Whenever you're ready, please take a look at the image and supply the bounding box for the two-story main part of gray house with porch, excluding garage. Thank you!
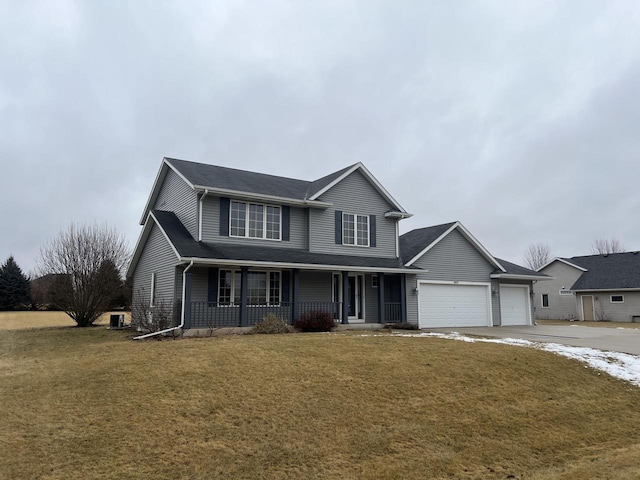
[128,158,413,328]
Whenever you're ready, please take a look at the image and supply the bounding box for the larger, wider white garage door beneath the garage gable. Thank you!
[418,283,491,328]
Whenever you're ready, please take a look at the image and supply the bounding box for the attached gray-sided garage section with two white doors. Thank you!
[400,222,548,328]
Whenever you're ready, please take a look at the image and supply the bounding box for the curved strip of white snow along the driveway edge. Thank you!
[378,332,640,387]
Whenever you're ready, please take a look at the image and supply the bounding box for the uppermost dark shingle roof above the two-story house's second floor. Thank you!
[166,158,353,200]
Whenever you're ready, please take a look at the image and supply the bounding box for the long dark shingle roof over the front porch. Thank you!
[153,210,412,269]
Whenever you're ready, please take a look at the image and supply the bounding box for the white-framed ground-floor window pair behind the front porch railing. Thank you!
[218,269,281,305]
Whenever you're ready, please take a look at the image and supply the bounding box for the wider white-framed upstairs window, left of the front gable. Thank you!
[229,200,282,240]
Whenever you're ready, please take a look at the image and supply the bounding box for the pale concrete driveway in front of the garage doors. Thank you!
[427,325,640,355]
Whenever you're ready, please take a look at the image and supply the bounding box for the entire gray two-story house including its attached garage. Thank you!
[127,158,545,328]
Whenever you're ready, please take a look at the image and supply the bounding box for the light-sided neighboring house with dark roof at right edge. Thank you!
[534,252,640,322]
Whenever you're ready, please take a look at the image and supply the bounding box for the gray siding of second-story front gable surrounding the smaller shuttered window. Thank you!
[309,171,396,258]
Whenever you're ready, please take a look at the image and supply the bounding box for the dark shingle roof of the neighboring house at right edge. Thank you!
[563,252,640,290]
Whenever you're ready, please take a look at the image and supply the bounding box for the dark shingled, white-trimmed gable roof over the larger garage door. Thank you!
[400,222,506,272]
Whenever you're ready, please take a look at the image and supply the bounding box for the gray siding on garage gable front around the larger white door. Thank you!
[406,230,492,325]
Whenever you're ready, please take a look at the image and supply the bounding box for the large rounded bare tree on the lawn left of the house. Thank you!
[38,224,129,327]
